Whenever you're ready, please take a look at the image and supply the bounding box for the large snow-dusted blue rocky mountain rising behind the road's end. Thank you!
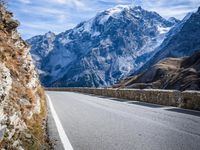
[28,6,179,87]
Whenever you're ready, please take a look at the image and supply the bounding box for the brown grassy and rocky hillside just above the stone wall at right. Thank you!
[114,51,200,91]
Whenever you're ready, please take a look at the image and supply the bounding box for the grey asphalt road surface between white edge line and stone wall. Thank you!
[47,92,200,150]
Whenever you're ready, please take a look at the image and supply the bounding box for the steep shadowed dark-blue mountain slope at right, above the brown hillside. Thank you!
[134,7,200,74]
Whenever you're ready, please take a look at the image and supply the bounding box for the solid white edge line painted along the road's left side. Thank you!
[46,94,73,150]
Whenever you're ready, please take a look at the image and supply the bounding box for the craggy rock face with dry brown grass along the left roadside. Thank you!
[0,5,46,150]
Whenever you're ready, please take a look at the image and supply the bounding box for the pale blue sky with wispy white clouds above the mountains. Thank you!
[8,0,200,39]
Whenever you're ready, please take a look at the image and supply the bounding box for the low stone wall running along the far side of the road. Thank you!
[46,88,200,110]
